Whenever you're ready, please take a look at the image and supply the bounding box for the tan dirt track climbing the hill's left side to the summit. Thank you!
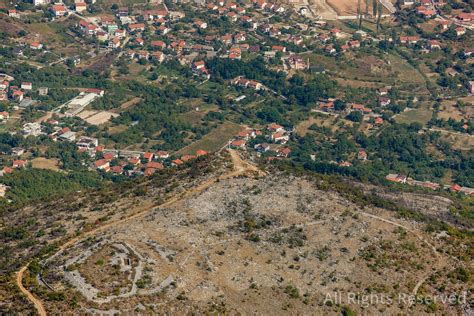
[16,149,265,316]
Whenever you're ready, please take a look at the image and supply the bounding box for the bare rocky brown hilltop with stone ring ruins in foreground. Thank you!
[39,175,472,315]
